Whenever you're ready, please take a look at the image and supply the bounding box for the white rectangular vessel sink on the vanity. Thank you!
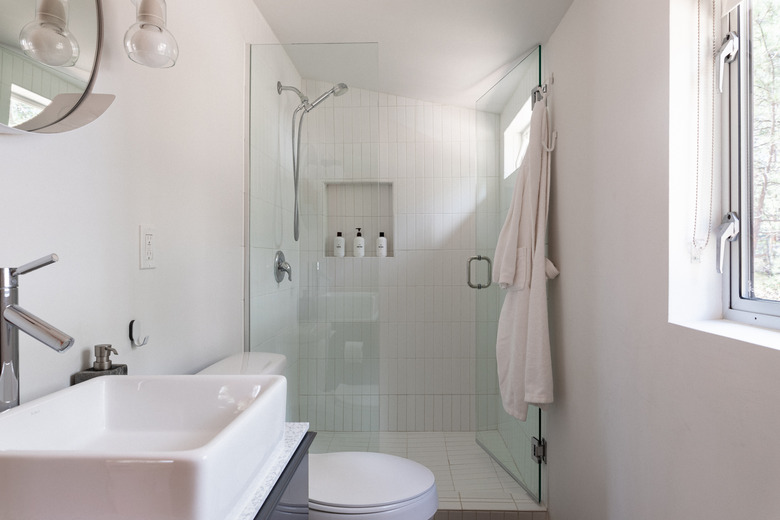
[0,375,287,520]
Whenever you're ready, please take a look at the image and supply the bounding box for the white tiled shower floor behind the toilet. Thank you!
[310,432,545,511]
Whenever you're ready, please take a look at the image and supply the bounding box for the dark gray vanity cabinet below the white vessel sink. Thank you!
[255,432,317,520]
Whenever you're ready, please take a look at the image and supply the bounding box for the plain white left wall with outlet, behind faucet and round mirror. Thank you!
[0,0,276,401]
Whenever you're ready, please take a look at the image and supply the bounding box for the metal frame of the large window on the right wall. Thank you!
[721,0,780,329]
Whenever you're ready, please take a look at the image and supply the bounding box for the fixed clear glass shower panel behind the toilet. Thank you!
[246,43,382,432]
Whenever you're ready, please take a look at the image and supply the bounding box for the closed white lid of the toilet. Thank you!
[309,452,434,508]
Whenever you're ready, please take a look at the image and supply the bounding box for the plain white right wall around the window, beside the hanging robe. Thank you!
[545,0,780,520]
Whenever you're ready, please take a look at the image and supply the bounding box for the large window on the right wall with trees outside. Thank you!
[718,0,780,328]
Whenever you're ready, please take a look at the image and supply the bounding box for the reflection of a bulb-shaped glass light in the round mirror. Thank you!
[19,0,79,67]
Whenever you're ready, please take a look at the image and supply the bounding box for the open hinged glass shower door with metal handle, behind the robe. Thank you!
[469,48,543,501]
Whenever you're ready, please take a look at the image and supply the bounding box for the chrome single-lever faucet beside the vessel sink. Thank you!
[0,254,74,412]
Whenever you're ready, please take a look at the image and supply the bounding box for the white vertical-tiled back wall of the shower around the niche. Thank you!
[301,80,484,431]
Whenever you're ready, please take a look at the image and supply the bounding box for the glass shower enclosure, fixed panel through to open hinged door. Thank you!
[251,39,544,500]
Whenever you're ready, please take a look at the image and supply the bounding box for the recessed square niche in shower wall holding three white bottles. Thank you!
[325,181,395,257]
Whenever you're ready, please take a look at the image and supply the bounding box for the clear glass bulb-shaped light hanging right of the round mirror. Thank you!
[125,0,179,68]
